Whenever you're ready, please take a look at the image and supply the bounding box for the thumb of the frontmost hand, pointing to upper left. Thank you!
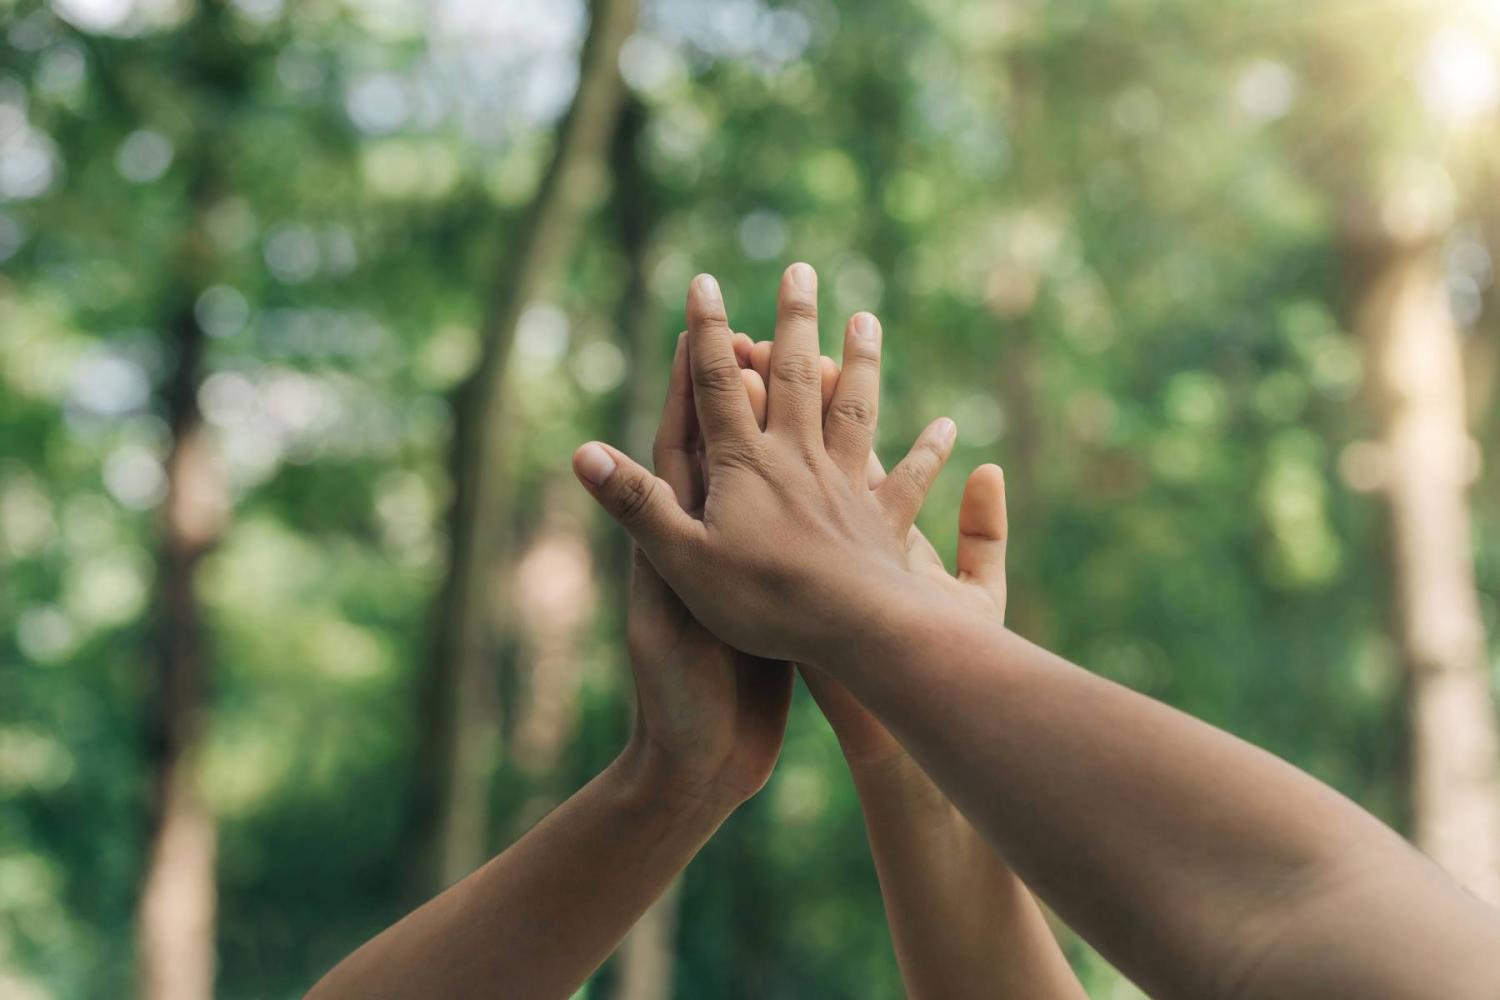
[573,441,704,566]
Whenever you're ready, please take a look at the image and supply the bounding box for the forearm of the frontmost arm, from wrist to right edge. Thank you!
[819,598,1500,997]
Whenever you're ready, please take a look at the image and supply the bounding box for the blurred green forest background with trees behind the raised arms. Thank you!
[0,0,1500,1000]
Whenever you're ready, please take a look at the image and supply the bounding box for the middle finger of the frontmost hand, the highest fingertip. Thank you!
[767,264,822,444]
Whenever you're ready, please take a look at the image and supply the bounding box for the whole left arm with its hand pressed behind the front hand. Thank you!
[309,343,792,1000]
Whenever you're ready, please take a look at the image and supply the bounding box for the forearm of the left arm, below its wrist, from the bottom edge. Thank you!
[309,750,729,1000]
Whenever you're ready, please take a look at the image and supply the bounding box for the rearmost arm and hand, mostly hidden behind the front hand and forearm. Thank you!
[747,335,1086,1000]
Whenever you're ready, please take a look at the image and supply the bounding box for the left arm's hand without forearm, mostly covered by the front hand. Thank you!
[626,334,792,808]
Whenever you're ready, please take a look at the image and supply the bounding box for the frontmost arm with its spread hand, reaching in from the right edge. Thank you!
[575,264,1500,1000]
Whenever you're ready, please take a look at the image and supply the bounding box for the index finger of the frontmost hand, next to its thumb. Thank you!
[687,274,756,460]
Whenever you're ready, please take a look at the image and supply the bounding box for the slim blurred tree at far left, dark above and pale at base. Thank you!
[137,3,254,1000]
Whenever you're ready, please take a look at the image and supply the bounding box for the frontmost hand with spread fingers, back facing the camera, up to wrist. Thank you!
[573,264,956,663]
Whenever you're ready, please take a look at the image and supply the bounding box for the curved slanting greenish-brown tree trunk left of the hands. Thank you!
[414,0,639,888]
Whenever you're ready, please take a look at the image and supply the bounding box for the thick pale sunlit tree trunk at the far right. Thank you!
[1355,230,1500,903]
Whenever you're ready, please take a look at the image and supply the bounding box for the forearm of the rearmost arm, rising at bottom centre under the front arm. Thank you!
[851,753,1085,1000]
